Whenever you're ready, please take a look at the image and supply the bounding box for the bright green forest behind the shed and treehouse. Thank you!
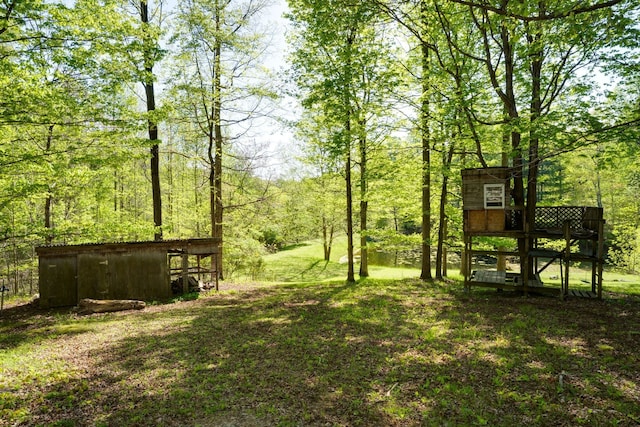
[0,0,640,294]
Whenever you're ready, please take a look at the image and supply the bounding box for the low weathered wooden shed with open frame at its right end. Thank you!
[36,238,220,308]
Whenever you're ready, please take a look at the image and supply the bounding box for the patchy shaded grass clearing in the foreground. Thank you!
[0,279,640,426]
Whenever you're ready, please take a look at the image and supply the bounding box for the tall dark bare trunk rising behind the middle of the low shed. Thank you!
[140,0,162,240]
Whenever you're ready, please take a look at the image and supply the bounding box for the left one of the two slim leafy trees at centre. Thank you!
[289,0,362,283]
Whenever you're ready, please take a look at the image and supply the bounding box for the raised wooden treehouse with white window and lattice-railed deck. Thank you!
[462,167,605,298]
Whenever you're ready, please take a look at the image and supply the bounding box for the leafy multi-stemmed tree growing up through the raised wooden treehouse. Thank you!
[436,0,634,280]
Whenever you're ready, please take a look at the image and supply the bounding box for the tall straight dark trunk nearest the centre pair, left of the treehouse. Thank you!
[420,34,432,280]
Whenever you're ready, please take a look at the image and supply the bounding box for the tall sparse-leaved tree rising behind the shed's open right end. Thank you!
[172,0,273,276]
